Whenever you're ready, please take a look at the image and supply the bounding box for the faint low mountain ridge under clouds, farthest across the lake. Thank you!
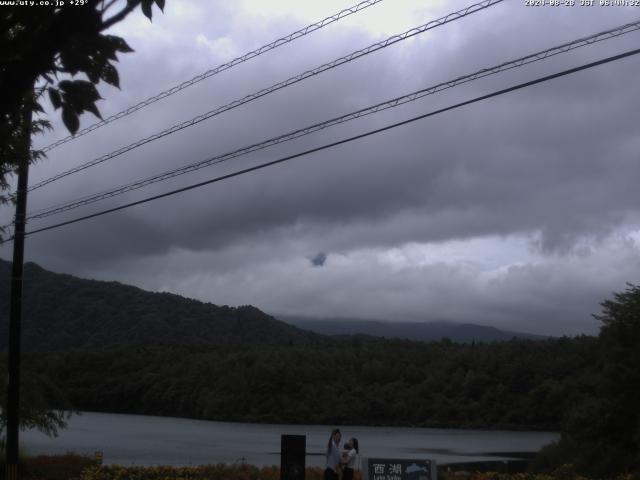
[278,315,548,343]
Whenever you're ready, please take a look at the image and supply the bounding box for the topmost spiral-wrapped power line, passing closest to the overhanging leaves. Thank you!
[42,0,382,153]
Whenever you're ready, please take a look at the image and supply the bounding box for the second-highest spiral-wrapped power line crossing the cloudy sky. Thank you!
[29,0,504,191]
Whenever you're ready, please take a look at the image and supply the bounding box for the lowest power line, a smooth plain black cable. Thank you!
[7,49,640,243]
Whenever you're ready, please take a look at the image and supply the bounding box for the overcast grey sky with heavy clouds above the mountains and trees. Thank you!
[0,0,640,335]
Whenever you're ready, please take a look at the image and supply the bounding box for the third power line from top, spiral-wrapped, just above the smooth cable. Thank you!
[27,20,640,219]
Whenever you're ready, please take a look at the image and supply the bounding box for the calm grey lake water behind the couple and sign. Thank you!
[20,412,559,466]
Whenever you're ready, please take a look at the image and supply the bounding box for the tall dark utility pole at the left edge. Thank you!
[6,90,34,480]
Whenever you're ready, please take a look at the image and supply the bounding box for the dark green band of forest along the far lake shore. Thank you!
[26,337,596,430]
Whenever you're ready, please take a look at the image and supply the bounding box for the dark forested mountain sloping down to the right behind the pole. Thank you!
[0,260,319,351]
